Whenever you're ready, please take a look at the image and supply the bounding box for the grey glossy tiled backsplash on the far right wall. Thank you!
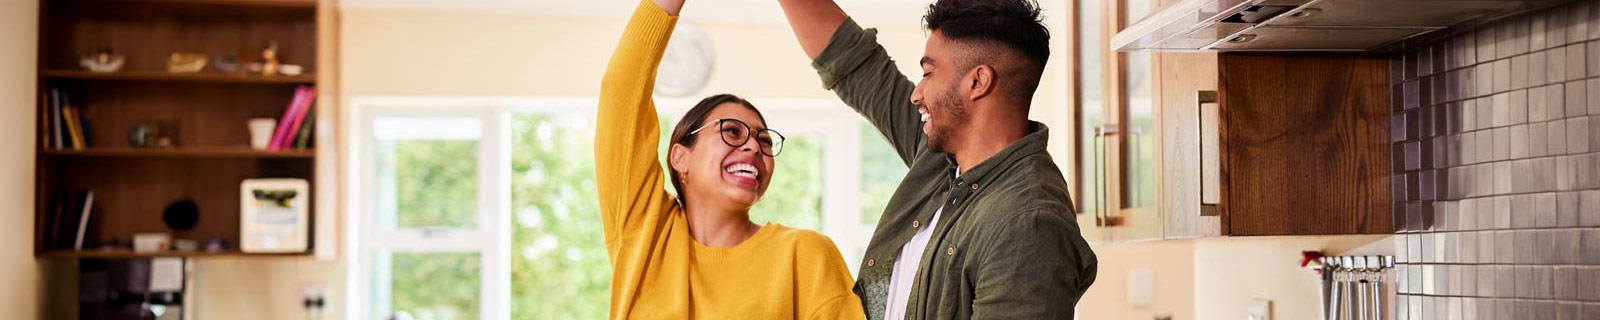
[1390,0,1600,320]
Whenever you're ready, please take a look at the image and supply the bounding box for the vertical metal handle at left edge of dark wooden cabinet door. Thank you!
[1195,90,1222,216]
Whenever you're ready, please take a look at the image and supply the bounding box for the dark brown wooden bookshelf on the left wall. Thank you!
[34,0,336,259]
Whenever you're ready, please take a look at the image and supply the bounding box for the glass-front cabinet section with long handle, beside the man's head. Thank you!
[1072,0,1163,242]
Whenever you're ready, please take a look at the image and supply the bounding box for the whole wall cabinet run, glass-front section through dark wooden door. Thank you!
[1070,0,1394,243]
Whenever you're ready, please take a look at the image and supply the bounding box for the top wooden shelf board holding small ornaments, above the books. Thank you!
[38,70,317,85]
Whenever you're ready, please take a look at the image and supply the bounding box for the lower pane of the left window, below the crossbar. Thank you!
[387,253,483,320]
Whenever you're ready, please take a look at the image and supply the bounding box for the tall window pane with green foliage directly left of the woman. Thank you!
[510,114,611,318]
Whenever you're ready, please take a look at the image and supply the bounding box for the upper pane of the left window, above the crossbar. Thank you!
[373,117,482,229]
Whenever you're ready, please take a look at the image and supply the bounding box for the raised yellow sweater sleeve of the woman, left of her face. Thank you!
[594,0,678,262]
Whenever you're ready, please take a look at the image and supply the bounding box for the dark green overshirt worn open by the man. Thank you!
[811,19,1096,320]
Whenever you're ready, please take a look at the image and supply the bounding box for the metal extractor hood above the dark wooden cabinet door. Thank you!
[1110,0,1570,51]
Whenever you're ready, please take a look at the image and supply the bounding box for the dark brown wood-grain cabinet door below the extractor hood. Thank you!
[1219,53,1394,235]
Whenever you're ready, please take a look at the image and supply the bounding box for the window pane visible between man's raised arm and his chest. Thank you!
[859,123,909,225]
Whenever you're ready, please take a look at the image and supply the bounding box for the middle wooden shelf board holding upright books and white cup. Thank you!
[40,147,317,158]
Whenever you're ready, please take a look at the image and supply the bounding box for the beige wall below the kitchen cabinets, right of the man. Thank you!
[1078,235,1394,320]
